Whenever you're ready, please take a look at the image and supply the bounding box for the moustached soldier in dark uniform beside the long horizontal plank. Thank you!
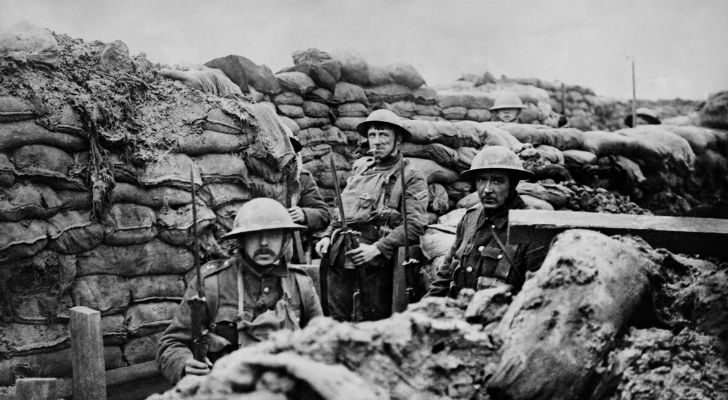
[427,146,545,298]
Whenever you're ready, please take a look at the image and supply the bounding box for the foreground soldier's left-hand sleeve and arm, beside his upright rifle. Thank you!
[157,280,207,383]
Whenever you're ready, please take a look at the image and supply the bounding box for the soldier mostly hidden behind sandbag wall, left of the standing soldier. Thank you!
[288,134,330,263]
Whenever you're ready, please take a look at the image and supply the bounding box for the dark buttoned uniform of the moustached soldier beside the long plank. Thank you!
[427,194,546,297]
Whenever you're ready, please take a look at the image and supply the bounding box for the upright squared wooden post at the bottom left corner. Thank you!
[71,306,106,400]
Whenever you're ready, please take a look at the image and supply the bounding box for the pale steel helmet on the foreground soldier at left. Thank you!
[221,197,306,239]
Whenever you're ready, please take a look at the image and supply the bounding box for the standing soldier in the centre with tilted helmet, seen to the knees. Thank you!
[316,110,428,320]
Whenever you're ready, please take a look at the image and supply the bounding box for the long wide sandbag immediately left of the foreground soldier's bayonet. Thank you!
[76,240,194,276]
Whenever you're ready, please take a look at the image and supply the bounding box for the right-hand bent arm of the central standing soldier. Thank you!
[375,170,428,259]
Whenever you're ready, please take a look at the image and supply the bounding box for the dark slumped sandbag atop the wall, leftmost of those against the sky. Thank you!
[205,55,281,94]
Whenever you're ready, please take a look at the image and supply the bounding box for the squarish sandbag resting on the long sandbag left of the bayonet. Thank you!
[104,203,157,246]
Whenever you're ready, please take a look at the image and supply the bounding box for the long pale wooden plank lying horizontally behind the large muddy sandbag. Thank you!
[508,210,728,258]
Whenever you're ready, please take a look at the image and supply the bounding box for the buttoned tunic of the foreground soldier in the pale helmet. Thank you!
[157,255,323,382]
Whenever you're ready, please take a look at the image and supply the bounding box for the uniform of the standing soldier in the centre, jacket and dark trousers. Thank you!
[321,153,428,320]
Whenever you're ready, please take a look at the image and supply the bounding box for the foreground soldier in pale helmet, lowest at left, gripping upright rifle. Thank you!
[157,198,323,383]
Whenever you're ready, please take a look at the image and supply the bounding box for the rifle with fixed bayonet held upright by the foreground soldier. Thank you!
[187,168,207,362]
